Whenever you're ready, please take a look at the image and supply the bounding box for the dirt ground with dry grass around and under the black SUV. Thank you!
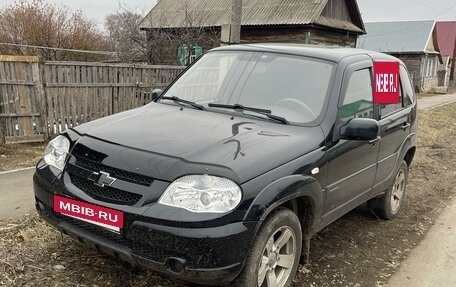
[0,104,456,287]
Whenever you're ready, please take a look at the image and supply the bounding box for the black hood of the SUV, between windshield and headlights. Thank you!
[73,103,324,183]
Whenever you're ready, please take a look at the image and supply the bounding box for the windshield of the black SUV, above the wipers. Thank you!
[160,52,334,123]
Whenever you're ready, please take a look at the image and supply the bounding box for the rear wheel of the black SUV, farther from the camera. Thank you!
[367,161,408,220]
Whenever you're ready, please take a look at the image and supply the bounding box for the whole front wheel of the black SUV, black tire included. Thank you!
[231,208,302,287]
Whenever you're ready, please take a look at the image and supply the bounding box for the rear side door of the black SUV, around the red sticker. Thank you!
[374,66,414,192]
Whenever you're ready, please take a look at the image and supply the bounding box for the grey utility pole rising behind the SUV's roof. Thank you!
[221,0,242,46]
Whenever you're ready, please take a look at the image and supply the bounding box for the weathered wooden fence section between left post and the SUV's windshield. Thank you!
[43,62,182,134]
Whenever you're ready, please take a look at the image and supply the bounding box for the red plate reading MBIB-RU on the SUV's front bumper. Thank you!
[54,195,124,232]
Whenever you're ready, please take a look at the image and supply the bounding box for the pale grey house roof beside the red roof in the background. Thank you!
[357,20,440,54]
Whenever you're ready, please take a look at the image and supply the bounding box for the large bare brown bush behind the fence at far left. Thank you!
[0,0,107,60]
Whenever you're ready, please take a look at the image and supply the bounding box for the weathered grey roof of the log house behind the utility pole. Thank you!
[140,0,364,34]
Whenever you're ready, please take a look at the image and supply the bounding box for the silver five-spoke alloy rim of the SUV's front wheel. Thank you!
[258,226,296,287]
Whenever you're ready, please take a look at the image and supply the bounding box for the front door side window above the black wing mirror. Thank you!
[339,69,374,125]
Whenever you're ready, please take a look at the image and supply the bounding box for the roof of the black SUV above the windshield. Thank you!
[214,43,401,63]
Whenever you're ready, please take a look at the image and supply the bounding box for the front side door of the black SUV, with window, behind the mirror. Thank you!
[324,60,379,223]
